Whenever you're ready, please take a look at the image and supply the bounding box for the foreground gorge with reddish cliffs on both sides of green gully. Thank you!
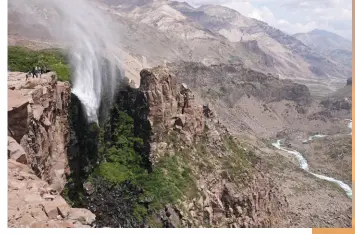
[8,67,289,227]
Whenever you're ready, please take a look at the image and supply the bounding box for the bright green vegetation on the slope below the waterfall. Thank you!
[86,106,196,220]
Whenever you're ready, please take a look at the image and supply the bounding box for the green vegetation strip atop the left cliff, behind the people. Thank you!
[8,46,71,81]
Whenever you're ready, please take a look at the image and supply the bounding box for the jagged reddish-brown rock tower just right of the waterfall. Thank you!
[139,67,204,163]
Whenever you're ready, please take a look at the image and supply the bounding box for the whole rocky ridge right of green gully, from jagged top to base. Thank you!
[139,67,288,227]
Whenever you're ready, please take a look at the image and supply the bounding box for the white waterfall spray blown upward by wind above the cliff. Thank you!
[9,0,122,122]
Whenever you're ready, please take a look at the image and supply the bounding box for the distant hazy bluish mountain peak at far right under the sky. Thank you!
[294,29,352,69]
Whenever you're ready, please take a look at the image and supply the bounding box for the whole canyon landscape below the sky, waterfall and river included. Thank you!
[7,0,352,228]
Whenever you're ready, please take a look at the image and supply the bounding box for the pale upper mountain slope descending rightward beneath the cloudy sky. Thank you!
[170,2,350,77]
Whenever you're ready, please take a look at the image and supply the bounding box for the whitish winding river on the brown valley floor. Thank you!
[272,120,353,199]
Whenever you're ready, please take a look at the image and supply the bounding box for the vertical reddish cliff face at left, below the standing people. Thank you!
[8,72,70,192]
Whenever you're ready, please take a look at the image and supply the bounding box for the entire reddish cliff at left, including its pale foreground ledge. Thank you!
[8,72,95,228]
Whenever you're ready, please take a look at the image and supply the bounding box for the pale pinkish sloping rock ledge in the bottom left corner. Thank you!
[8,159,95,228]
